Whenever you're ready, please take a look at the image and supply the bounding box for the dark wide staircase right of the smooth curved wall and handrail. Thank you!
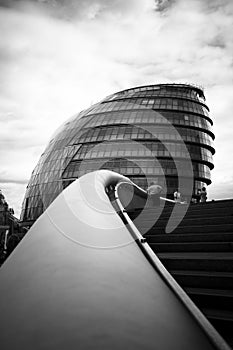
[128,200,233,348]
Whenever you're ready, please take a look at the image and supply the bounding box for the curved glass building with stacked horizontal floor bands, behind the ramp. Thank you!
[21,84,215,222]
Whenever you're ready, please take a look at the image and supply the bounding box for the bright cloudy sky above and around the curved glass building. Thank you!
[0,0,233,216]
